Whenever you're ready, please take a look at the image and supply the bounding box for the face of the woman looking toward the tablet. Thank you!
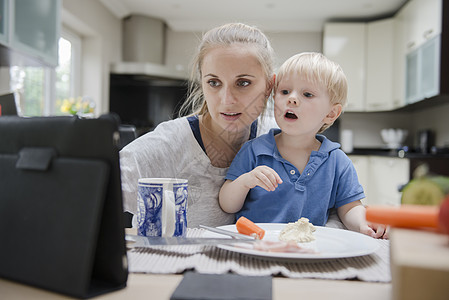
[201,44,271,133]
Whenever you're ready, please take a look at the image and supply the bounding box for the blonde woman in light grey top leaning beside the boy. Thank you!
[120,23,274,227]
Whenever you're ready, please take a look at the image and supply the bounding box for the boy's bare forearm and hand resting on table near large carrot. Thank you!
[337,200,387,238]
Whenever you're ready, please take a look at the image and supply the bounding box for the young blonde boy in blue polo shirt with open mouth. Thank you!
[219,53,385,238]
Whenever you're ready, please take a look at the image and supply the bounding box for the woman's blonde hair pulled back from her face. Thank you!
[179,23,274,116]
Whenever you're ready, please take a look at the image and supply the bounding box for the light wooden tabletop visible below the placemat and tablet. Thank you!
[0,274,392,300]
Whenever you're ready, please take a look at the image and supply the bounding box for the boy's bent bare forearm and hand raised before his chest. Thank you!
[218,166,282,213]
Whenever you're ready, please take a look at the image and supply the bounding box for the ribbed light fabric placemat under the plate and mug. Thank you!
[128,229,391,282]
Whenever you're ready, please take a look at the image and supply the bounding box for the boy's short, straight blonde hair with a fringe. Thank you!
[275,52,348,133]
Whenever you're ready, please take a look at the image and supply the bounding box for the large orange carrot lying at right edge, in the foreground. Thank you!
[366,204,439,228]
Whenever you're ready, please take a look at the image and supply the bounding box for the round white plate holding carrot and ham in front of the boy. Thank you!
[203,223,379,259]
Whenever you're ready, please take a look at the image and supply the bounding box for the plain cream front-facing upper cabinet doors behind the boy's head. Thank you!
[323,18,405,111]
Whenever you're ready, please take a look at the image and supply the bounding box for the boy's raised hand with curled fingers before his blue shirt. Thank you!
[242,166,282,191]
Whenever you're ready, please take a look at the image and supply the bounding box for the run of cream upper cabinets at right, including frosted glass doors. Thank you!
[323,0,448,111]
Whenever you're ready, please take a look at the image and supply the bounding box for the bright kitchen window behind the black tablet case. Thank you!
[10,28,81,116]
